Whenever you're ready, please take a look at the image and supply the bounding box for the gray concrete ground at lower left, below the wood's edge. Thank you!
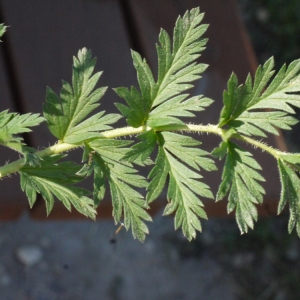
[0,214,236,300]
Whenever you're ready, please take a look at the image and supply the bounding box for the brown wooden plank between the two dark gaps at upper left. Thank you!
[1,0,136,217]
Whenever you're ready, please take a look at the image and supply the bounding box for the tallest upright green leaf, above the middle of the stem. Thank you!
[115,8,211,127]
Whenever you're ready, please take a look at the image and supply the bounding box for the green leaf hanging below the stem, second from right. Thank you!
[216,141,265,233]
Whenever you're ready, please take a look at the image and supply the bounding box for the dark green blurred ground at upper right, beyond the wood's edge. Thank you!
[239,0,300,152]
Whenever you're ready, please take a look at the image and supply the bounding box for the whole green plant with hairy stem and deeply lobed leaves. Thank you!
[0,8,300,241]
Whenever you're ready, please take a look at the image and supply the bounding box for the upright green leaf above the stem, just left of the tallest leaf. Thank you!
[43,48,112,143]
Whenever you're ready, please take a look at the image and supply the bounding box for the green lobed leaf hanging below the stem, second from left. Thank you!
[88,139,152,241]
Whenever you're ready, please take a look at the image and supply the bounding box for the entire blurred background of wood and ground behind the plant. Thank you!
[0,0,300,300]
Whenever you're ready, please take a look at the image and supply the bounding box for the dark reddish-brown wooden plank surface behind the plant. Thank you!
[0,0,285,220]
